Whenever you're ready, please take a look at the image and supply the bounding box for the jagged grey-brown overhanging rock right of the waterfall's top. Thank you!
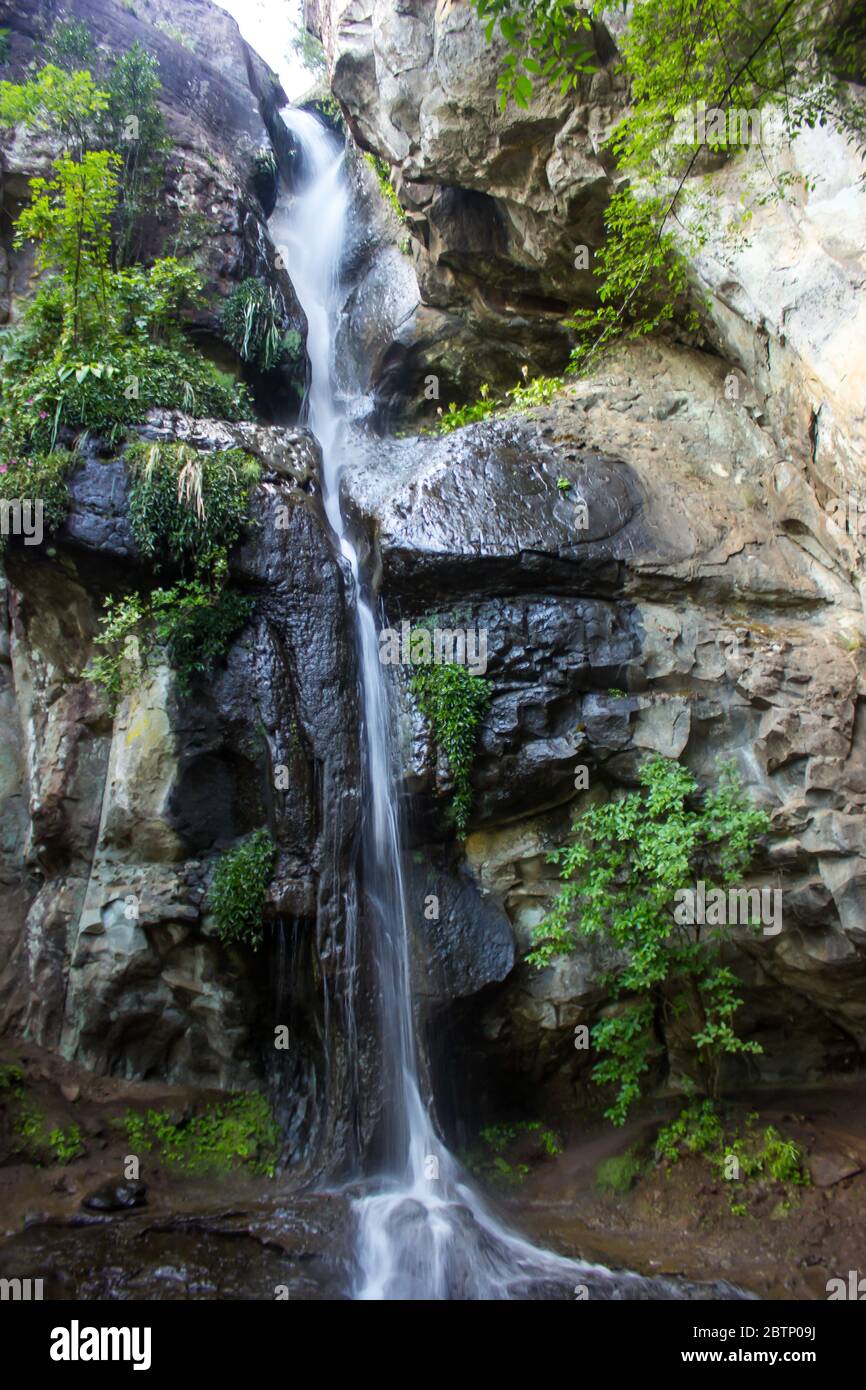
[306,0,623,393]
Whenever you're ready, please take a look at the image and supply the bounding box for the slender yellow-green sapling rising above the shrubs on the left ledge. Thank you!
[15,150,121,346]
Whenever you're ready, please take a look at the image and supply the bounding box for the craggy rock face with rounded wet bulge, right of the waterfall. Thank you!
[346,345,866,1115]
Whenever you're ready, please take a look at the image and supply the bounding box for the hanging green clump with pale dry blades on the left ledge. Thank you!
[125,442,261,566]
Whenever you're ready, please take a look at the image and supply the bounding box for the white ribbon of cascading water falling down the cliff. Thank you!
[271,110,739,1300]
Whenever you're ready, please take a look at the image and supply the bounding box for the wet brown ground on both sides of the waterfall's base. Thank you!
[0,1048,866,1301]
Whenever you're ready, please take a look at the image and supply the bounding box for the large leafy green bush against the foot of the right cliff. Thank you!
[527,758,769,1125]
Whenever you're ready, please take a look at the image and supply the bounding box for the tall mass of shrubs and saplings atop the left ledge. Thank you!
[0,54,250,461]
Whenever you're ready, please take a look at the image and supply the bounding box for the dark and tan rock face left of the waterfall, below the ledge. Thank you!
[1,413,360,1156]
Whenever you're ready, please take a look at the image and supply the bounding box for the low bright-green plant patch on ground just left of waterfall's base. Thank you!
[121,1093,279,1177]
